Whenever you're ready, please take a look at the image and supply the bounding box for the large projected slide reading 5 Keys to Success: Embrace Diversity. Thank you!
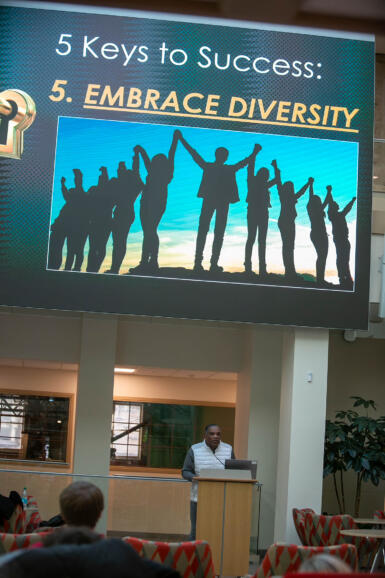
[0,2,374,329]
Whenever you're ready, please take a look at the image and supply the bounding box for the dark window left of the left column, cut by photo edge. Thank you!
[0,393,70,462]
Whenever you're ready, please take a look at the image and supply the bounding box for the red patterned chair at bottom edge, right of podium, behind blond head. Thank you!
[254,544,357,578]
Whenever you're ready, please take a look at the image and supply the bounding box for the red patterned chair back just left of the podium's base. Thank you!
[123,536,215,578]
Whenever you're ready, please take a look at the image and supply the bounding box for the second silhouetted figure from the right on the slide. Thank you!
[306,177,329,285]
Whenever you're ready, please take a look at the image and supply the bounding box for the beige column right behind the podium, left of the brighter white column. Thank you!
[235,327,282,549]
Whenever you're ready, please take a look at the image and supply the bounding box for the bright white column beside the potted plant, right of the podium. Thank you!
[274,328,329,543]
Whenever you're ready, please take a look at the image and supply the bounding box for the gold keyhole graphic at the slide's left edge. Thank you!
[0,89,36,159]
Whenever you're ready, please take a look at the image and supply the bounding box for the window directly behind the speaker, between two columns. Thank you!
[111,401,235,469]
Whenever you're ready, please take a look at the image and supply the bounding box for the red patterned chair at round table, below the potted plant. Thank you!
[305,513,378,567]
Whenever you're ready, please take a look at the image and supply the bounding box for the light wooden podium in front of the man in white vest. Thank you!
[194,470,257,576]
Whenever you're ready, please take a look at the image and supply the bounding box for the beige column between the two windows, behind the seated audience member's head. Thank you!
[73,315,117,532]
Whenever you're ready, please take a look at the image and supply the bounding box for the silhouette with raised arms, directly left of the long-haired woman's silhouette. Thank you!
[106,151,144,273]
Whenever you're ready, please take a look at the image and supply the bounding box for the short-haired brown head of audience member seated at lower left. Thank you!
[59,482,104,529]
